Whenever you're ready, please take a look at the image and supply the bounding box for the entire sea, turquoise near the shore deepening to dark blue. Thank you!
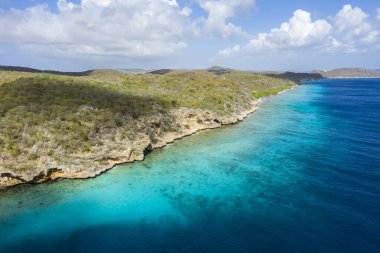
[0,79,380,253]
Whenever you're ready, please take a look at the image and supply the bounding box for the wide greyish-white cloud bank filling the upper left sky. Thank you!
[0,0,192,57]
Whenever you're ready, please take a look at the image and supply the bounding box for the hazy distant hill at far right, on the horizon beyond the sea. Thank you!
[314,68,380,78]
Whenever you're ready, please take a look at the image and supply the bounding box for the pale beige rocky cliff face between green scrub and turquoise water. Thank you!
[0,101,259,189]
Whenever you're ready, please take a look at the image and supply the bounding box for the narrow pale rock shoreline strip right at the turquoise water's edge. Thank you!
[0,86,296,191]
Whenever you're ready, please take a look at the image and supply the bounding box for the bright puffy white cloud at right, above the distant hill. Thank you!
[219,5,380,56]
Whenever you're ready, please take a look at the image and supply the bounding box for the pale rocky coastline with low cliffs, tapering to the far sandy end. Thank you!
[0,86,296,191]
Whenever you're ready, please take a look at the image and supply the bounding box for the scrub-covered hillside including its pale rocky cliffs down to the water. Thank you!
[0,69,294,187]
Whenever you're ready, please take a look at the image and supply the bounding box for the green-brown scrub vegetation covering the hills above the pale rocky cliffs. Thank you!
[0,70,294,167]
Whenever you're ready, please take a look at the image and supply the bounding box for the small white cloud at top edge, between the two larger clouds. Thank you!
[197,0,255,38]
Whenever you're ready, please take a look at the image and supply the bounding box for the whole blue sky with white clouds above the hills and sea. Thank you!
[0,0,380,71]
